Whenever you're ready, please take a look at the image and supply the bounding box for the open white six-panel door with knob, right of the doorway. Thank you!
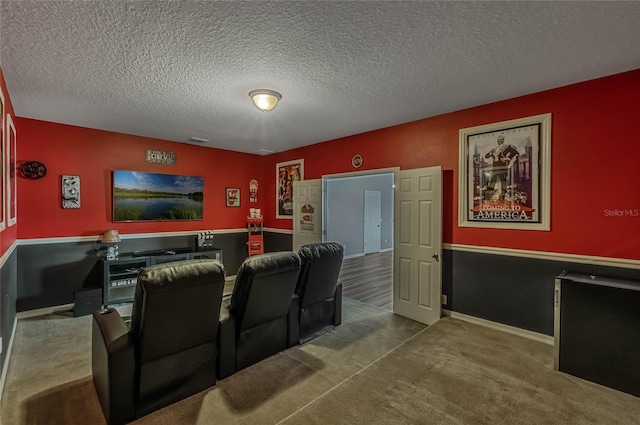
[393,166,442,325]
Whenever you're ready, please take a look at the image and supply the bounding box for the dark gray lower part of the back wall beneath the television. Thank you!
[16,231,247,312]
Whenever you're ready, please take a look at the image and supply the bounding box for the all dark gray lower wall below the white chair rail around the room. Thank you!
[17,231,640,338]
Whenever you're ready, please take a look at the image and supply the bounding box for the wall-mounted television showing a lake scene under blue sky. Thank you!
[113,170,204,221]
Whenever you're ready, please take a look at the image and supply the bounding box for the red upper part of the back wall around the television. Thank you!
[16,118,264,239]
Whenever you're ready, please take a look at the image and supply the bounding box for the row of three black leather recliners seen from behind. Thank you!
[92,242,343,424]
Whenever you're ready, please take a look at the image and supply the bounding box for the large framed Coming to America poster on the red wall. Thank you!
[458,114,551,230]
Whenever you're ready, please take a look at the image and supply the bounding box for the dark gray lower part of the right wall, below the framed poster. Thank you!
[443,251,640,335]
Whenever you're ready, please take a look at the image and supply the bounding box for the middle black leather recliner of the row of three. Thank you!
[218,251,300,379]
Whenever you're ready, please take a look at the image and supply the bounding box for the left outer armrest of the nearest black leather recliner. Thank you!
[91,308,135,425]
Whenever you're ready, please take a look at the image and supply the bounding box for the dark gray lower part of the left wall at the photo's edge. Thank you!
[0,251,17,370]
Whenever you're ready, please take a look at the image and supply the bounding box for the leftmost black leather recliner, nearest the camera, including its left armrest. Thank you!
[92,260,225,424]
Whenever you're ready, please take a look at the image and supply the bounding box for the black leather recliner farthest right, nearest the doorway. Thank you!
[291,242,344,345]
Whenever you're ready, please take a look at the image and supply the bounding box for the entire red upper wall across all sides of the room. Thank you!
[6,70,640,260]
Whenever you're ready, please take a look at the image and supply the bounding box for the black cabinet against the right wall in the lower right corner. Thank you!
[554,271,640,396]
